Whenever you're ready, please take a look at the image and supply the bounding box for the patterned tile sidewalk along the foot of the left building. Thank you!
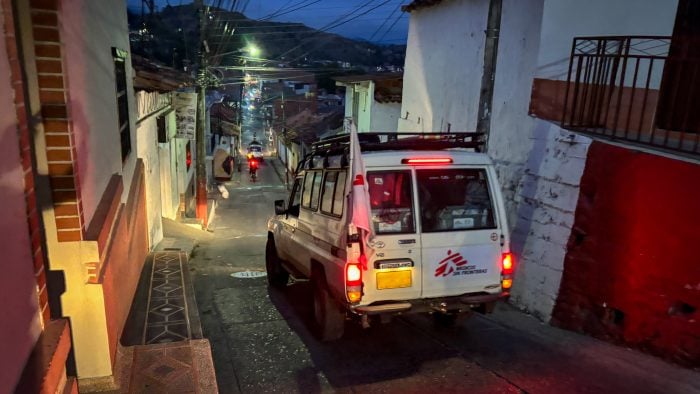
[112,220,218,394]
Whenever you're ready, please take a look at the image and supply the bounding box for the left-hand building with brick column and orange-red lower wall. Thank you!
[0,0,151,392]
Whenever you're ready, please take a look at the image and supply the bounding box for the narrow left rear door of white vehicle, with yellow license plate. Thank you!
[363,169,422,302]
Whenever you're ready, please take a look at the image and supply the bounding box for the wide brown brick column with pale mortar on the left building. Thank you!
[30,0,85,242]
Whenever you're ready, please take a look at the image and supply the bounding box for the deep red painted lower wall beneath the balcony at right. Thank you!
[552,142,700,366]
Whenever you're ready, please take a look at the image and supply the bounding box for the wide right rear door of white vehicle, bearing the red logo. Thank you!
[416,168,502,298]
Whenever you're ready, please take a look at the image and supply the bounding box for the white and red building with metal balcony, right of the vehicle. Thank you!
[398,0,700,365]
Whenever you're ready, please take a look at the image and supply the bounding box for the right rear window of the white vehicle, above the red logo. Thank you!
[416,169,496,232]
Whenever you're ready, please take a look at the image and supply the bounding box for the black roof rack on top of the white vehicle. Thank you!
[296,132,484,172]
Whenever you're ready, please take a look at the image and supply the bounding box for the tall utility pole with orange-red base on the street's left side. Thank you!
[195,0,209,228]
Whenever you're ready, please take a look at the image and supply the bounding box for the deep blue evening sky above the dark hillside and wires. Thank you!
[127,0,411,44]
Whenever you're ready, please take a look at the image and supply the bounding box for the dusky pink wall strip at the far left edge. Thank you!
[0,3,41,393]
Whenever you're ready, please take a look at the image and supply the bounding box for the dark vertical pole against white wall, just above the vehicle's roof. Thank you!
[476,0,503,152]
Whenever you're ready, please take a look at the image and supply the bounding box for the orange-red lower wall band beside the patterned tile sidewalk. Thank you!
[100,160,148,366]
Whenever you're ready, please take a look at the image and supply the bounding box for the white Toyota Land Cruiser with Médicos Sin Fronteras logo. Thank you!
[266,133,513,340]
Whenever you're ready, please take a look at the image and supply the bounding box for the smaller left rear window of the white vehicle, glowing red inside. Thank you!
[367,171,415,234]
